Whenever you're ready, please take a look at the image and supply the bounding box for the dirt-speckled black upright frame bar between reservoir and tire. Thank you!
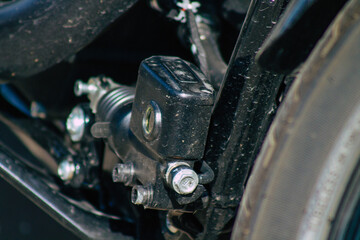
[200,0,288,239]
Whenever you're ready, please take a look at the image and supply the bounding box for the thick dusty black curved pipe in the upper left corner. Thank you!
[0,0,137,80]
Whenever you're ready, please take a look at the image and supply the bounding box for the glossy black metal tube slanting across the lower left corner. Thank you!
[0,147,132,239]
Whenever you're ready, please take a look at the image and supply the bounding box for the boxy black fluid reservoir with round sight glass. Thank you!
[130,56,215,160]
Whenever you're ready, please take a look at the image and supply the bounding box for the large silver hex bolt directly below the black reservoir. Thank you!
[166,163,199,195]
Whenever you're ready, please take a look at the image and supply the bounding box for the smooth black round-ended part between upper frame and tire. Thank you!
[258,0,347,73]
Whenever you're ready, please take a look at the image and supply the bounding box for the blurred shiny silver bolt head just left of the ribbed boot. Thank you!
[66,106,86,142]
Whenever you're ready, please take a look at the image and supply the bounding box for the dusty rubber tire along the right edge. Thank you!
[232,0,360,240]
